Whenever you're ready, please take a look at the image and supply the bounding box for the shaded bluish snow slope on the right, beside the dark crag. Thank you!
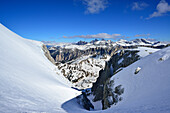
[106,47,170,113]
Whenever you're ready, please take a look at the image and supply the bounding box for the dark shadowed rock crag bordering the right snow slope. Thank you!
[92,50,139,109]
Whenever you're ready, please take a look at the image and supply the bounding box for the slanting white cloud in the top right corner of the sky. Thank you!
[146,0,170,19]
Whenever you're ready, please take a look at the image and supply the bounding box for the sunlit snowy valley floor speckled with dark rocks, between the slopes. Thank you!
[57,55,110,89]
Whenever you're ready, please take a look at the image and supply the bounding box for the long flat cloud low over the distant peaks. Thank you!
[63,33,125,39]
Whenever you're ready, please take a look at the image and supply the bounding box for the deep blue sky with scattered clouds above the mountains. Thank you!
[0,0,170,42]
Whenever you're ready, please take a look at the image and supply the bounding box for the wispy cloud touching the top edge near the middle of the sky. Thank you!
[83,0,108,14]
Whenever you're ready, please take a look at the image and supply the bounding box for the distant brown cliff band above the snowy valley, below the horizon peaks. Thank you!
[50,46,122,63]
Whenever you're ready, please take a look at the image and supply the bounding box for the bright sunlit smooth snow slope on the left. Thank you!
[0,24,79,113]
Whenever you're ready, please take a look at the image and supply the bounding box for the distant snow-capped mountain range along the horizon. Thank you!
[43,38,170,50]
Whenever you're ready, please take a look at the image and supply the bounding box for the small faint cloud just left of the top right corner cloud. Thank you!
[132,2,148,10]
